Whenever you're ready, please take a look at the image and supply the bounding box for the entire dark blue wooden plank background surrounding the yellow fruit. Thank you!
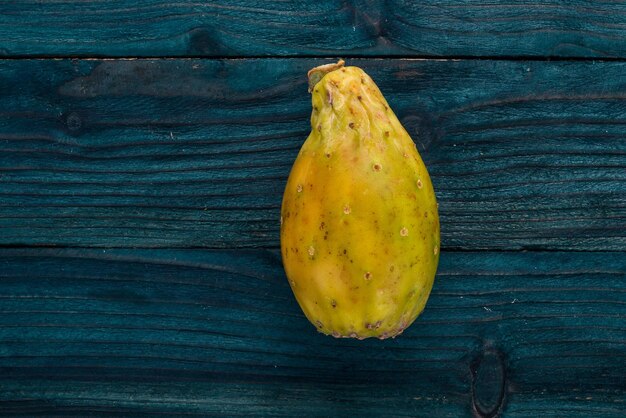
[0,0,626,417]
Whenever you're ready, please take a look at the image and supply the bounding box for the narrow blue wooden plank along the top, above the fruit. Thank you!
[0,0,626,58]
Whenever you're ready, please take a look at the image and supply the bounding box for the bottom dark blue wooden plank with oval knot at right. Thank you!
[0,249,626,417]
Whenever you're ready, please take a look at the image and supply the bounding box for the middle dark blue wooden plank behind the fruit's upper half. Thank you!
[0,59,626,250]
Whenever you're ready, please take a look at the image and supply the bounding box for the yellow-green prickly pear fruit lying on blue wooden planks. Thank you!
[281,61,440,339]
